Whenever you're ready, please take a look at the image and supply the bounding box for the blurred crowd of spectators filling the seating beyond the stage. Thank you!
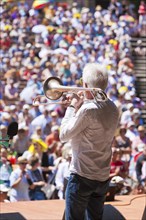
[0,0,146,201]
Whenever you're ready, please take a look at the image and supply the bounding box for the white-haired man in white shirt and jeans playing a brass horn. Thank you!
[60,63,119,220]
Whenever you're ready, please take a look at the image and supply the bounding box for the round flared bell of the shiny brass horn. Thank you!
[43,77,63,100]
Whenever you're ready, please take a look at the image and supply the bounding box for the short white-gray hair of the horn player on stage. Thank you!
[82,63,108,90]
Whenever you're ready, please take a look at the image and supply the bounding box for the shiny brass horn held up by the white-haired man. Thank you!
[33,77,107,106]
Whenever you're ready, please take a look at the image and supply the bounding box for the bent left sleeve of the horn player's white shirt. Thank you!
[60,107,88,142]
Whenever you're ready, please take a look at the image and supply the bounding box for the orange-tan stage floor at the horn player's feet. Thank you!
[0,194,146,220]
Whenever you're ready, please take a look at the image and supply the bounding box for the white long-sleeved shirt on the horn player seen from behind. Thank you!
[60,100,119,181]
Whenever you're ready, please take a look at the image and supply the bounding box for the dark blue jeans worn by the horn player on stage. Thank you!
[65,174,109,220]
